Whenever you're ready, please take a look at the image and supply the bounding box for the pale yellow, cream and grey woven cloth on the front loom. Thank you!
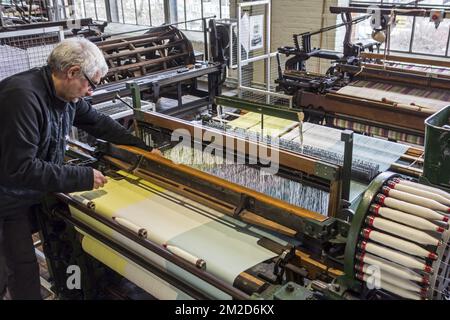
[71,172,275,284]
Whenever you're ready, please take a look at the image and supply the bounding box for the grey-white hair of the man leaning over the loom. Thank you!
[47,38,108,79]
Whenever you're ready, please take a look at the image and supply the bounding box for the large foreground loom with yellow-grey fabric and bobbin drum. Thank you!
[39,76,450,299]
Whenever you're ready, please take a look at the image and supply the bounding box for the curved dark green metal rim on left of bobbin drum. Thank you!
[339,171,399,290]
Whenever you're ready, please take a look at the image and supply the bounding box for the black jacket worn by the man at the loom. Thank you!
[0,67,149,216]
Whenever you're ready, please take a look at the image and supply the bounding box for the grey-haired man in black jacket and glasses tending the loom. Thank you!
[0,38,159,299]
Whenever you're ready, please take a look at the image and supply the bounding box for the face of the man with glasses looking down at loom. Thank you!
[62,66,101,102]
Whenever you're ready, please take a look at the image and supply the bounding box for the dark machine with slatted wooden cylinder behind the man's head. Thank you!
[84,19,226,122]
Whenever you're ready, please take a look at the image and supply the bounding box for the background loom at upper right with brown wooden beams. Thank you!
[276,5,450,145]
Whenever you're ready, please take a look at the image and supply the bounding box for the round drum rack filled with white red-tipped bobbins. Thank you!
[344,172,450,299]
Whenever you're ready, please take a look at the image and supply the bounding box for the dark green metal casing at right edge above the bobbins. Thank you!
[421,106,450,191]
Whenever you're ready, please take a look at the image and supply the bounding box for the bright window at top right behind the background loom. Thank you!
[350,0,450,57]
